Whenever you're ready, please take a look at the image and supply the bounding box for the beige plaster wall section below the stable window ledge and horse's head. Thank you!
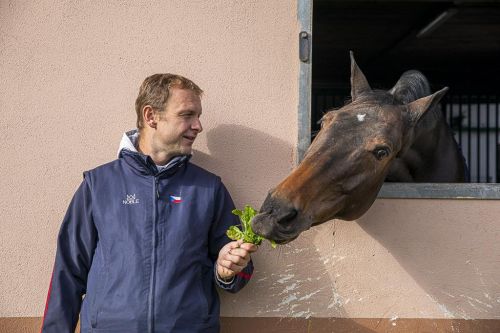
[223,199,500,320]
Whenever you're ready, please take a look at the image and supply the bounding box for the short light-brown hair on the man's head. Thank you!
[135,73,203,130]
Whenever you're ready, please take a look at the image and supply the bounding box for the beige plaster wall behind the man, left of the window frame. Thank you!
[0,0,298,317]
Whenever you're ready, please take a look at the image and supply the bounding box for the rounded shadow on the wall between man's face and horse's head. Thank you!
[192,124,293,208]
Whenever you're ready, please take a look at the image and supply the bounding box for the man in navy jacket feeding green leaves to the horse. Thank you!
[42,74,257,333]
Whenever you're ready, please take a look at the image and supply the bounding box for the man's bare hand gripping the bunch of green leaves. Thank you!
[217,240,257,280]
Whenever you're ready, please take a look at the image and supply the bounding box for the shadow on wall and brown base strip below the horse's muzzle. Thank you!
[221,224,376,333]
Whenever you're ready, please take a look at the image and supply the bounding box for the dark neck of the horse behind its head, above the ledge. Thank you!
[388,108,465,182]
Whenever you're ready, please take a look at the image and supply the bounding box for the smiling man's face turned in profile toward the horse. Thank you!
[154,88,203,157]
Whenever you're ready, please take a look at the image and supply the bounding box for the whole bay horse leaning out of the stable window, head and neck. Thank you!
[252,52,466,243]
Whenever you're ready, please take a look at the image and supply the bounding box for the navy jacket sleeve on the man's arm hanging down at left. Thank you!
[41,179,97,333]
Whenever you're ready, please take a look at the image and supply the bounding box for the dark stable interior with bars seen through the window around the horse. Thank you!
[311,0,500,183]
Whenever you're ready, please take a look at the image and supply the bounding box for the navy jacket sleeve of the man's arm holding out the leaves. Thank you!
[209,178,253,293]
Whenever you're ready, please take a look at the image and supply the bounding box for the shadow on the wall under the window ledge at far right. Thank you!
[357,200,500,319]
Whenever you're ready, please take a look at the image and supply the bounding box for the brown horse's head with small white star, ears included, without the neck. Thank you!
[252,52,447,243]
